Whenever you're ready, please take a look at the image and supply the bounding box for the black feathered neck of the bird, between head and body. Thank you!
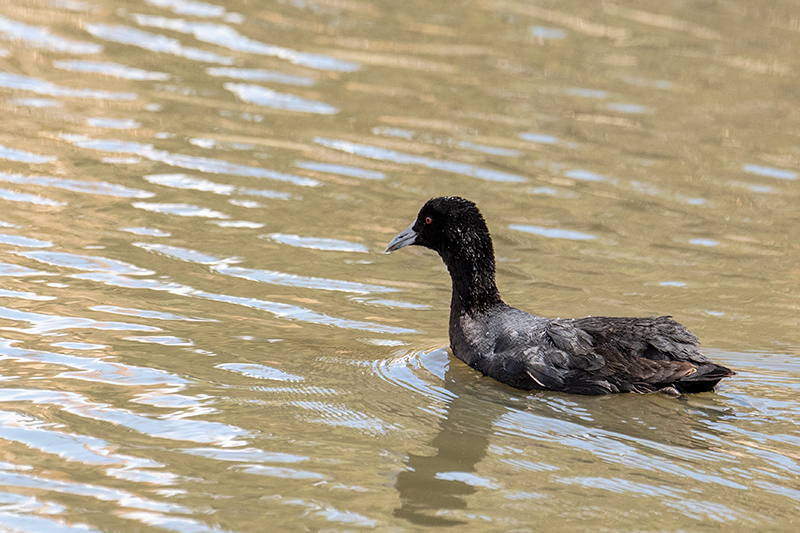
[442,242,503,314]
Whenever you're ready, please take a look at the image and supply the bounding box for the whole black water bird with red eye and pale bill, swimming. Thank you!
[386,196,735,396]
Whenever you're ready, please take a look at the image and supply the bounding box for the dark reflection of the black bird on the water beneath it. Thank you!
[394,349,734,527]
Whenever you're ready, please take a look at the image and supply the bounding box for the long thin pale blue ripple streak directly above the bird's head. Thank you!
[314,137,527,183]
